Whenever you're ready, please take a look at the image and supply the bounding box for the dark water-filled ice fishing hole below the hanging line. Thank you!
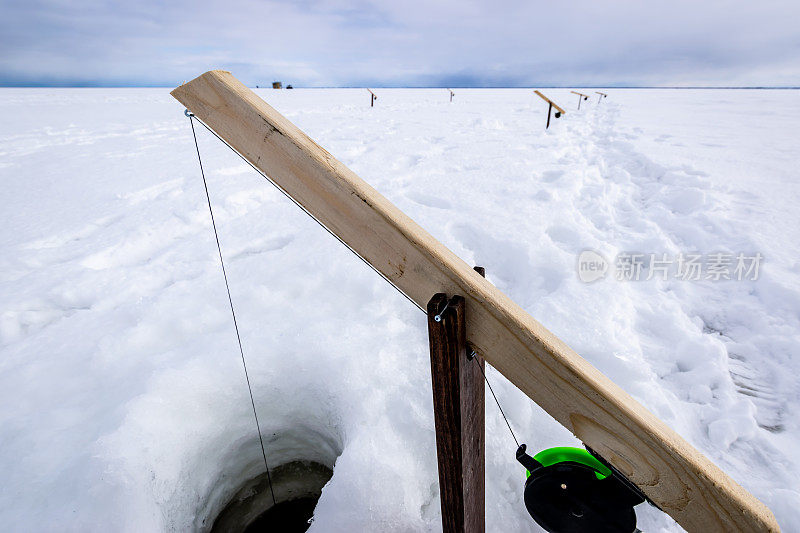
[211,461,333,533]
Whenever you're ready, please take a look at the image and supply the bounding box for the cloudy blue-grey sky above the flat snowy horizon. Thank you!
[0,0,800,87]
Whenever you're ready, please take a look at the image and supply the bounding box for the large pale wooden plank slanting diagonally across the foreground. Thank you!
[172,71,779,532]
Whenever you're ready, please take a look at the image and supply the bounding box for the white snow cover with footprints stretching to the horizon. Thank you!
[0,89,800,533]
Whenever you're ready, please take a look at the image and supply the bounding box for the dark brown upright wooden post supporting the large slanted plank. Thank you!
[427,293,486,533]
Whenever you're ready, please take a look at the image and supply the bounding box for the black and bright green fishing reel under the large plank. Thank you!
[517,444,647,533]
